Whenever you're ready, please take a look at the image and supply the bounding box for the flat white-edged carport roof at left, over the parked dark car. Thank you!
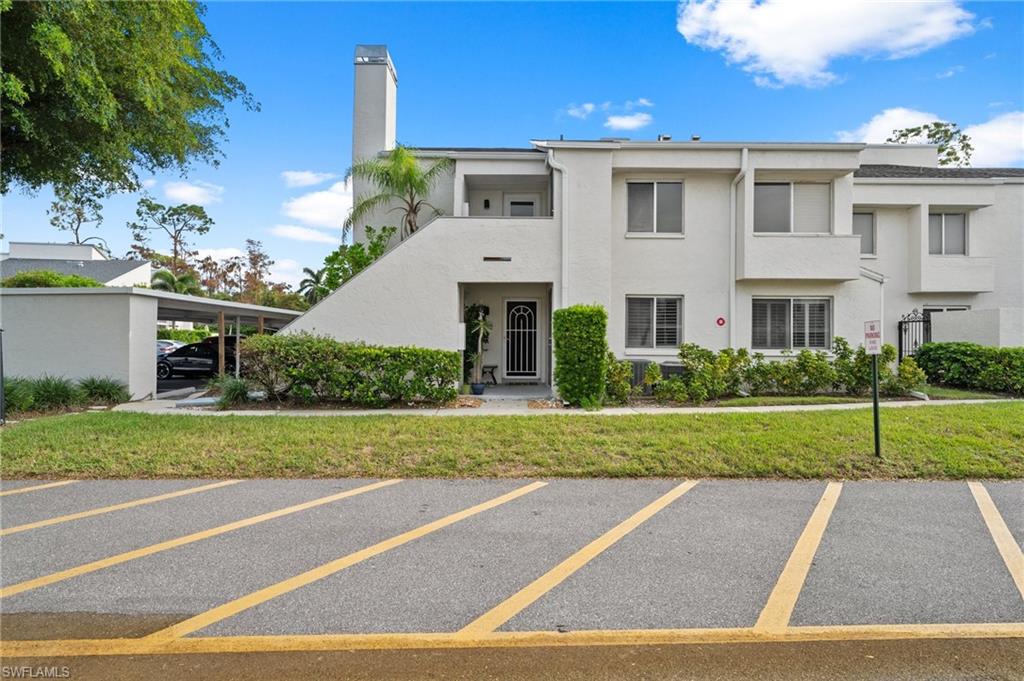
[0,287,302,329]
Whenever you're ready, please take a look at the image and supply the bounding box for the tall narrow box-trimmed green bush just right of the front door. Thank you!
[553,305,608,406]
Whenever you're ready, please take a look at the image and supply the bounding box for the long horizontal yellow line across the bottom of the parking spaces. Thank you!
[0,623,1024,657]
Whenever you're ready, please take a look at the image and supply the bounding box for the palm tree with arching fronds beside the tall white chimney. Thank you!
[345,144,453,239]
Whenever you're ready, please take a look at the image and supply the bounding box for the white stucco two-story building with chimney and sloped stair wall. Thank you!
[287,45,1024,384]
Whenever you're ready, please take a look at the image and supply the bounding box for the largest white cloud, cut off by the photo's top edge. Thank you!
[676,0,976,87]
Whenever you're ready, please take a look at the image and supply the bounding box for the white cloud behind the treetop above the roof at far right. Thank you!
[836,108,1024,168]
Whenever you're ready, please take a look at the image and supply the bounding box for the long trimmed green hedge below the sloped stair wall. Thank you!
[241,334,462,408]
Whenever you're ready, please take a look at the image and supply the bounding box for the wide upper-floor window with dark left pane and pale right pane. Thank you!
[754,182,831,233]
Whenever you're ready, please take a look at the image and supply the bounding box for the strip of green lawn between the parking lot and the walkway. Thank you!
[0,402,1024,478]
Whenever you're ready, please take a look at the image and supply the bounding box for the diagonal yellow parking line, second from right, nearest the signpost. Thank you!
[754,482,843,631]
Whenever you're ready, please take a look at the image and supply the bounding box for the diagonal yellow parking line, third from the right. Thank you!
[457,480,696,638]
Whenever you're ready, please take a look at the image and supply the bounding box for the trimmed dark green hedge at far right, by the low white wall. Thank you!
[913,343,1024,395]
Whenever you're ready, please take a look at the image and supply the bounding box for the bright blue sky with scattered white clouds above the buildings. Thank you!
[3,0,1024,282]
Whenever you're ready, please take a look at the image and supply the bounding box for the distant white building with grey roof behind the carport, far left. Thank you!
[0,242,151,286]
